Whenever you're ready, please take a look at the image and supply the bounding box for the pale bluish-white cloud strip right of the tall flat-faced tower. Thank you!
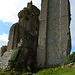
[70,0,75,47]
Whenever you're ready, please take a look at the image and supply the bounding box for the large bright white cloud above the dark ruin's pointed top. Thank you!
[0,0,41,23]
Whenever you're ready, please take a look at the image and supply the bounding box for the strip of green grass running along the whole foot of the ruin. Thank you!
[0,67,75,75]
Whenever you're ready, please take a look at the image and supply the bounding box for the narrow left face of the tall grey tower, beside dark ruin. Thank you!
[37,0,48,67]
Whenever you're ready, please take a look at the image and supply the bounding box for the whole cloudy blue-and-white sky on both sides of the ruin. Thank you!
[0,0,75,52]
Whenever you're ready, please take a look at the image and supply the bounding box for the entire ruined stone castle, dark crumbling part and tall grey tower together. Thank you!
[0,0,71,71]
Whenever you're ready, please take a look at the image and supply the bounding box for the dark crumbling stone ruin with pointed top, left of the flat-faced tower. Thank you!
[1,1,40,69]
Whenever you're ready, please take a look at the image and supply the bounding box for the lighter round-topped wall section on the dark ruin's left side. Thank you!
[7,23,20,50]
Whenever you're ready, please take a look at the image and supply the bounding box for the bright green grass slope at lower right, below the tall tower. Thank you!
[33,68,75,75]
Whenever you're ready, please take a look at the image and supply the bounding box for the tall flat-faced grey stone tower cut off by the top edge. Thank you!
[37,0,71,68]
